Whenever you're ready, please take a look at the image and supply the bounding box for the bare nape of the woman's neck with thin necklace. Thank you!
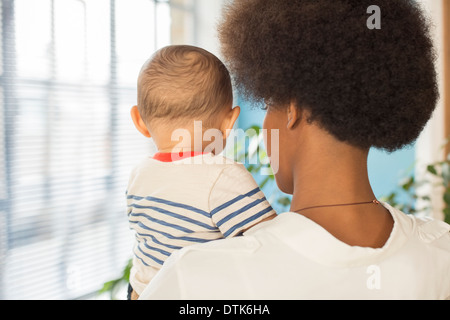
[291,129,393,248]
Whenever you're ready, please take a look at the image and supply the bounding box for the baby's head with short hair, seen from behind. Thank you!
[132,45,239,154]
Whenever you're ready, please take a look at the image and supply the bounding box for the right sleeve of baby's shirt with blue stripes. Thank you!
[209,164,276,238]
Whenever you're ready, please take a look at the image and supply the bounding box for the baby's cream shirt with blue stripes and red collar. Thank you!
[127,154,275,294]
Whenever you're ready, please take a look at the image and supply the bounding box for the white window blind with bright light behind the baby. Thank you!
[0,0,190,299]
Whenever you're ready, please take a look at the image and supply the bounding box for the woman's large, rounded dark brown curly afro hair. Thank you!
[219,0,439,151]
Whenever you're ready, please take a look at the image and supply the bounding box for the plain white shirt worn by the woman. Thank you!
[140,204,450,300]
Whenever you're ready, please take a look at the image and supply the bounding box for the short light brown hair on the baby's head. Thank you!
[138,45,233,123]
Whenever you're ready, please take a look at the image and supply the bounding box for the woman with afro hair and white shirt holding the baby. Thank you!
[142,0,450,299]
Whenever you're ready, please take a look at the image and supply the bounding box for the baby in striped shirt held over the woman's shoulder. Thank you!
[127,45,275,299]
